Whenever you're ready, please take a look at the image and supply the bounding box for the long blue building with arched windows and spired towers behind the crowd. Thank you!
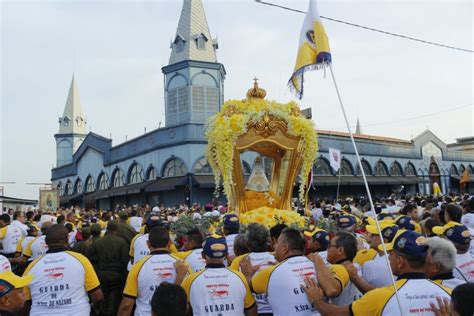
[51,0,474,209]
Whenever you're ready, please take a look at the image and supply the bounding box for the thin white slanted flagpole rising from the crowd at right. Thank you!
[328,63,403,314]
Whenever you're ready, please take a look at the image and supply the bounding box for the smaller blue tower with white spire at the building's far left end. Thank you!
[54,75,87,167]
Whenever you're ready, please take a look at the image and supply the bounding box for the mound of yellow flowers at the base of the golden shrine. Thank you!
[240,206,306,229]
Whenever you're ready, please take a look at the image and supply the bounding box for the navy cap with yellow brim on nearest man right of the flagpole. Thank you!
[379,229,428,257]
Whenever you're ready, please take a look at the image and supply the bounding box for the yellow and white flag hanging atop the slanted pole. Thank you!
[288,0,331,99]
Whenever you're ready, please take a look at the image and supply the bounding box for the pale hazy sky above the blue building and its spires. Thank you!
[0,0,474,199]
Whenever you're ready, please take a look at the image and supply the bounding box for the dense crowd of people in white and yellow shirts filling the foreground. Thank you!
[0,195,474,316]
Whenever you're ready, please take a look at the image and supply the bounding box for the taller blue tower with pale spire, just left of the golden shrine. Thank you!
[162,0,226,126]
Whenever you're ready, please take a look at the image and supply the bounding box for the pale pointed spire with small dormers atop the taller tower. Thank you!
[169,0,218,65]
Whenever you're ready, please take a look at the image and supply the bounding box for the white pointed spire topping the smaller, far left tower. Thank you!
[59,74,87,134]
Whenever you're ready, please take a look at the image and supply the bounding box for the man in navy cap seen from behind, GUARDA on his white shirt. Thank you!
[181,235,257,316]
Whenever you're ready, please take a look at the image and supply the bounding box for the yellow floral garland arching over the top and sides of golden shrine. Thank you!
[206,98,318,202]
